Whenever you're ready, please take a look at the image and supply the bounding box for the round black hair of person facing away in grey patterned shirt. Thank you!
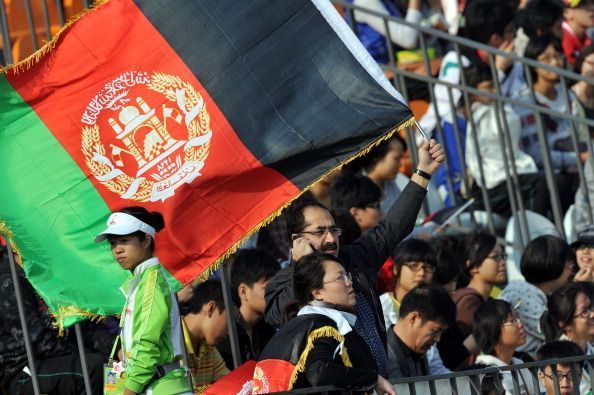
[520,235,575,284]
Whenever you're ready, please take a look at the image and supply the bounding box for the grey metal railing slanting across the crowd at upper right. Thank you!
[332,0,594,254]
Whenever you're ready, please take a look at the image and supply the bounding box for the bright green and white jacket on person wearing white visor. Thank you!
[121,258,183,393]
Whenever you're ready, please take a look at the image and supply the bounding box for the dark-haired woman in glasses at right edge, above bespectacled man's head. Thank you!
[541,283,594,394]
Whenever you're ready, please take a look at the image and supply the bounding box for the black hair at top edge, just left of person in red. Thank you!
[516,0,565,39]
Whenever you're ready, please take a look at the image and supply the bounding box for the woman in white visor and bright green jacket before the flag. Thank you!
[95,207,191,395]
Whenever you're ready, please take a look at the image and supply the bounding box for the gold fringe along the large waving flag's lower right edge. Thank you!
[191,116,416,283]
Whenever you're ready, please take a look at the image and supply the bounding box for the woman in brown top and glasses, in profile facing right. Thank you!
[454,233,507,337]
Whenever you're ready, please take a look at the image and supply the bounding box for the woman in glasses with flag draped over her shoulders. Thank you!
[253,252,395,395]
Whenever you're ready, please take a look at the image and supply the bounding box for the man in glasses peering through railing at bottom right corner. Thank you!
[537,340,584,395]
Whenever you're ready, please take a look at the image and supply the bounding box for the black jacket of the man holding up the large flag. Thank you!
[264,182,427,346]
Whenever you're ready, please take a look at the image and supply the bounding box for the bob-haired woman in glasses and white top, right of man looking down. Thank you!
[472,300,538,395]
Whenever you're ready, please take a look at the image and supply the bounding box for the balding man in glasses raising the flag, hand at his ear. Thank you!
[264,140,445,375]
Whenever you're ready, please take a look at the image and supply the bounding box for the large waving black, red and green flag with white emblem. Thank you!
[0,0,412,326]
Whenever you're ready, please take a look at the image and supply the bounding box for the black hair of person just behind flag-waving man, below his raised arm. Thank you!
[330,173,382,212]
